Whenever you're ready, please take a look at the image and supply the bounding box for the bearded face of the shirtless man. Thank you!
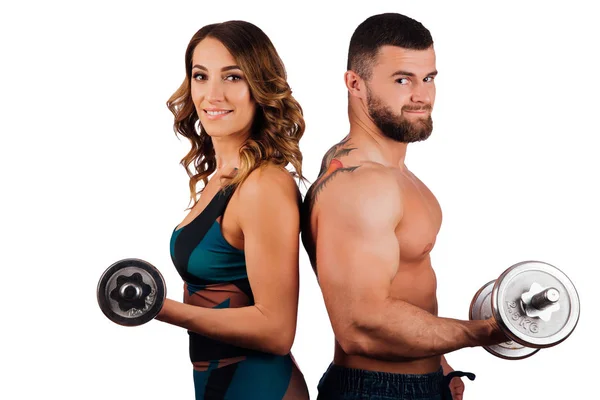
[365,46,437,143]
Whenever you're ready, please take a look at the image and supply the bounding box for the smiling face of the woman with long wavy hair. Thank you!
[191,37,256,138]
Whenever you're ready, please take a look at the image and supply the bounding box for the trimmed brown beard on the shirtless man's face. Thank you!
[367,87,433,143]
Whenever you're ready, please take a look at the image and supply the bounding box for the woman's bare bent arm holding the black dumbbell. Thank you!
[156,166,300,355]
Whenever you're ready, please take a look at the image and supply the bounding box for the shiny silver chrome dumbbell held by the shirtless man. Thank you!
[469,261,579,360]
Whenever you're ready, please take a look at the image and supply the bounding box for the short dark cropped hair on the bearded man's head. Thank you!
[347,13,433,80]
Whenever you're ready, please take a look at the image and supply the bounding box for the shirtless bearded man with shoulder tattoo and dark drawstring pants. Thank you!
[302,14,507,399]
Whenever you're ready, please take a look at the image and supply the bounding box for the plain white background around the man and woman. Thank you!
[0,0,600,400]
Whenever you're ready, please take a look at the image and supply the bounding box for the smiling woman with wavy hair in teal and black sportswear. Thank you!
[157,21,308,400]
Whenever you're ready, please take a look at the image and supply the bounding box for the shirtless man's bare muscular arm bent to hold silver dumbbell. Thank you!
[316,166,505,360]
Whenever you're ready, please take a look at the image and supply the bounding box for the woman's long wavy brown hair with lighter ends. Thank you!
[167,21,306,207]
